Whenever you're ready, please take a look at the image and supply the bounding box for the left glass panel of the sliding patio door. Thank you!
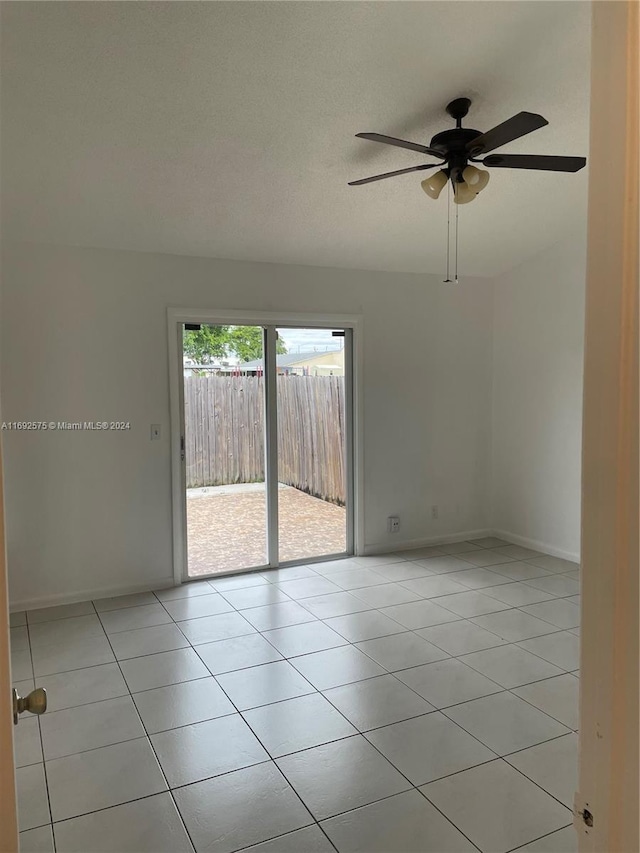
[182,324,269,578]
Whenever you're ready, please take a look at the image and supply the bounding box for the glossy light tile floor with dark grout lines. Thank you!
[11,537,579,853]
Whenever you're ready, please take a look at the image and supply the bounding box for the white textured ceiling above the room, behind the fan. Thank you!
[0,0,590,275]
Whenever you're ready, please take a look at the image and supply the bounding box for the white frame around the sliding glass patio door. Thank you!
[167,308,364,584]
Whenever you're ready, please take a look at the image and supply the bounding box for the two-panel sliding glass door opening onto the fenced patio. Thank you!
[180,323,353,579]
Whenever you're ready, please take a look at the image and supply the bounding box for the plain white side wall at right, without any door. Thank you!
[492,224,586,559]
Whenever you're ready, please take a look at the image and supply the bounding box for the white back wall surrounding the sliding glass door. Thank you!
[1,244,492,607]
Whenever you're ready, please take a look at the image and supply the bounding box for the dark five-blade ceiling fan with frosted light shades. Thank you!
[349,98,587,204]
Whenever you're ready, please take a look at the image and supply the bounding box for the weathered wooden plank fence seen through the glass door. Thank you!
[184,376,346,505]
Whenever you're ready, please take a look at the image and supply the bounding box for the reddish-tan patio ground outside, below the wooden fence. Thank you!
[187,483,346,577]
